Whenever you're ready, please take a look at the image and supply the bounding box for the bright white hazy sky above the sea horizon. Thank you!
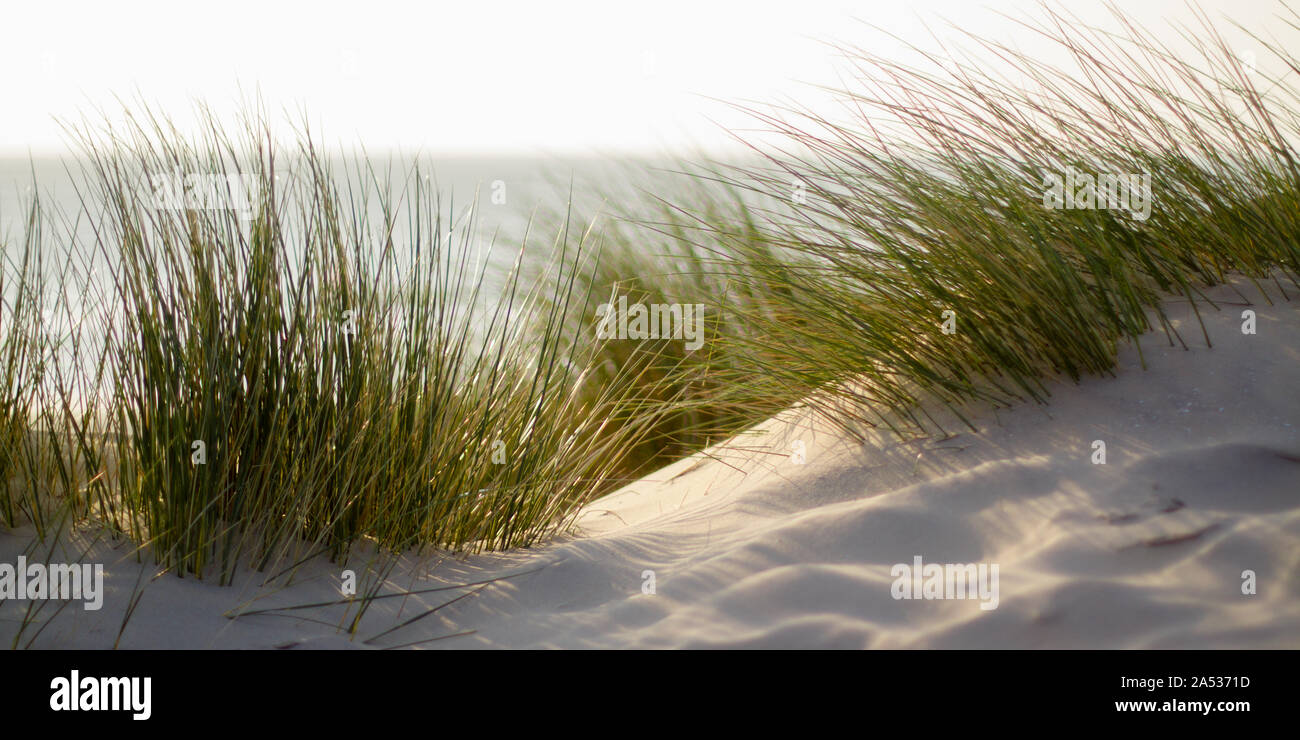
[0,0,1281,155]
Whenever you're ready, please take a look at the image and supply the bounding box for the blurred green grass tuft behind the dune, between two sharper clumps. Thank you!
[529,163,797,477]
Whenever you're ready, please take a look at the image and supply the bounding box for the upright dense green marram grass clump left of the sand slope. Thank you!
[29,104,655,581]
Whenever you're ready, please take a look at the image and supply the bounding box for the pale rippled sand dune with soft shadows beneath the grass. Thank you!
[0,275,1300,649]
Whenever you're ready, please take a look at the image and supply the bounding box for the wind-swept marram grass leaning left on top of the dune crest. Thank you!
[603,1,1300,433]
